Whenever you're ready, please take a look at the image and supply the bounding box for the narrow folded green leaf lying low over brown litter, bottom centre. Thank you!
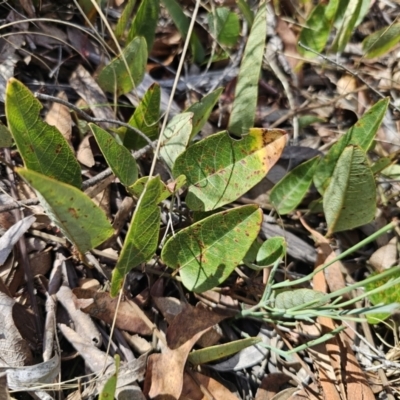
[188,338,261,365]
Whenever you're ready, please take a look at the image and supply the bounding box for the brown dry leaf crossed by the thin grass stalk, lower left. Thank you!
[73,288,152,335]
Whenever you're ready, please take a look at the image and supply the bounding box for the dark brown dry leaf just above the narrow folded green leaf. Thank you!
[167,304,228,349]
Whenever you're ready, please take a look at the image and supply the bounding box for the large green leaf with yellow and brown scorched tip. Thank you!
[173,128,287,211]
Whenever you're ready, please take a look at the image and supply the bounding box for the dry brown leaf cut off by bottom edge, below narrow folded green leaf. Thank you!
[179,372,238,400]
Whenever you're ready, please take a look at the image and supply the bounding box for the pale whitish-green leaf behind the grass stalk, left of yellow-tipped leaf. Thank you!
[160,112,193,170]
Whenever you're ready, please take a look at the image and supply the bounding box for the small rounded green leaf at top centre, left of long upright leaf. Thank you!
[208,7,240,46]
